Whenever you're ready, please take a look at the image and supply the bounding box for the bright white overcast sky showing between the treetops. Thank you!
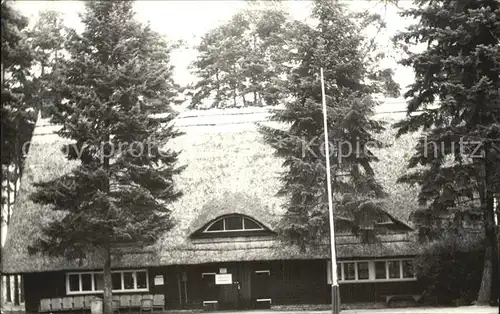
[11,0,413,100]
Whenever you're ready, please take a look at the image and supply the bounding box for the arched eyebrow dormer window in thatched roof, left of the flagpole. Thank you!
[192,214,274,237]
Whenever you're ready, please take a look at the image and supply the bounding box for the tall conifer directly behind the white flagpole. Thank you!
[262,1,397,247]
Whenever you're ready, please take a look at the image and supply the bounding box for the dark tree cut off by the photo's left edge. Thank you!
[0,1,35,304]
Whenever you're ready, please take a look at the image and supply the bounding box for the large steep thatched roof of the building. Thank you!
[2,108,416,273]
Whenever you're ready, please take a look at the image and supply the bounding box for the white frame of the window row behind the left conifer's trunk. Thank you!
[65,269,149,295]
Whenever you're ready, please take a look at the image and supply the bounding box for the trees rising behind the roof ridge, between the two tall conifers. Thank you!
[191,3,289,108]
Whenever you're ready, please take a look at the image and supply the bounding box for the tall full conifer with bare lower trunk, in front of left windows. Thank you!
[31,1,181,314]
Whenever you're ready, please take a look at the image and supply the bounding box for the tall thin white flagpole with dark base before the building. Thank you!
[320,68,340,314]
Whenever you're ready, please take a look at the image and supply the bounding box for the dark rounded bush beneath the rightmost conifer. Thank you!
[416,232,484,305]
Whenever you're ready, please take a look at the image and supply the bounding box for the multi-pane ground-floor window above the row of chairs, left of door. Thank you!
[66,270,148,294]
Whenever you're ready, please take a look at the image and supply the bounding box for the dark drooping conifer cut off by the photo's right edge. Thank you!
[396,0,500,303]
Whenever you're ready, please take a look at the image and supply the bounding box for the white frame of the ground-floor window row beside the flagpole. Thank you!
[326,258,417,284]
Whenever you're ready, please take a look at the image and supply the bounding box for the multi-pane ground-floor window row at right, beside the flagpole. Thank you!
[327,259,416,283]
